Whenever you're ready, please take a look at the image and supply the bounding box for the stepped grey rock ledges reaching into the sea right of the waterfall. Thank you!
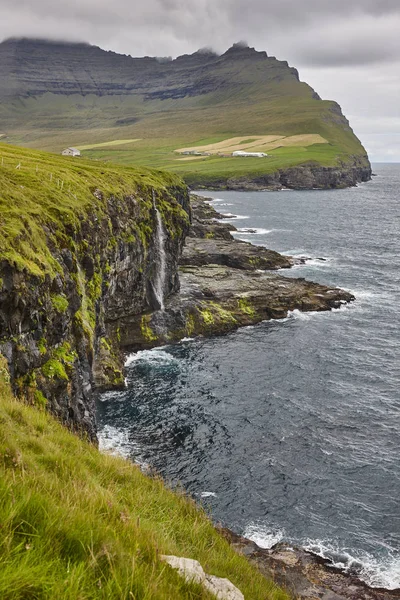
[115,195,355,351]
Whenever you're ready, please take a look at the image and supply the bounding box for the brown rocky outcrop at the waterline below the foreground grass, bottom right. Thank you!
[219,528,400,600]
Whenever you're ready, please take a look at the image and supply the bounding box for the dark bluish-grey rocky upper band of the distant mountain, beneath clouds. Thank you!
[0,38,298,101]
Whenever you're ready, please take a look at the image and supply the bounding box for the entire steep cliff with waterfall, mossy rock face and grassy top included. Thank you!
[0,147,189,439]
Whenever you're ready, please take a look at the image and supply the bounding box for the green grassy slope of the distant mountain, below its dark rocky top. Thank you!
[0,48,365,183]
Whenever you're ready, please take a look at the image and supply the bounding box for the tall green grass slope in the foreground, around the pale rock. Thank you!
[0,356,288,600]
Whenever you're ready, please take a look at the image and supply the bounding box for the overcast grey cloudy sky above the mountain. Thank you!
[0,0,400,162]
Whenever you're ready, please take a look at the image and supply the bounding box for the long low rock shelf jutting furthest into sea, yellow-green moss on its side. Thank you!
[115,265,354,350]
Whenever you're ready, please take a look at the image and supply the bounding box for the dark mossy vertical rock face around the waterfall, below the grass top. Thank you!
[0,184,189,440]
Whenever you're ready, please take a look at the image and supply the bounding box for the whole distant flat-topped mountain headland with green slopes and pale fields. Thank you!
[0,39,371,189]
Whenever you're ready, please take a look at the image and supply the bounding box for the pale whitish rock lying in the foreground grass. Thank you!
[160,556,244,600]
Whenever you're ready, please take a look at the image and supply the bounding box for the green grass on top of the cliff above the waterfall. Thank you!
[0,143,183,276]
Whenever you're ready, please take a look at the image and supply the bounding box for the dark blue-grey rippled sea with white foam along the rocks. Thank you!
[98,165,400,588]
